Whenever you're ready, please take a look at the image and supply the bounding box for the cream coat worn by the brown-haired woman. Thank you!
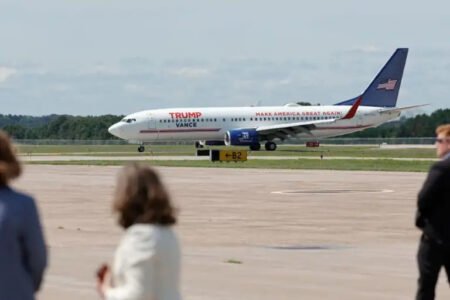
[106,224,181,300]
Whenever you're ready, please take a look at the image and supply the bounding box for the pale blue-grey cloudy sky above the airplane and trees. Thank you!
[0,0,450,115]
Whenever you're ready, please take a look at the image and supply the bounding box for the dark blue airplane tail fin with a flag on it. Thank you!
[336,48,408,107]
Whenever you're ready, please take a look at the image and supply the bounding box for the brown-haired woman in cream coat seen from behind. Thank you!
[97,164,181,300]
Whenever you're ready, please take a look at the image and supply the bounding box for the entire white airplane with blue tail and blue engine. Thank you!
[108,48,421,152]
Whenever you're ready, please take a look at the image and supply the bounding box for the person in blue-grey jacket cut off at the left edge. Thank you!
[0,130,47,300]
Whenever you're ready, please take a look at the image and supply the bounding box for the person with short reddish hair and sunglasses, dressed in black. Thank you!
[416,124,450,300]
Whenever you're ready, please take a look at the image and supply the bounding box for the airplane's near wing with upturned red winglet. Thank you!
[256,97,362,140]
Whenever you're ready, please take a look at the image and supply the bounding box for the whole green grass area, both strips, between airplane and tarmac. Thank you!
[17,145,436,172]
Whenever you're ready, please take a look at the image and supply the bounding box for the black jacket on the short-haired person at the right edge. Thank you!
[416,155,450,246]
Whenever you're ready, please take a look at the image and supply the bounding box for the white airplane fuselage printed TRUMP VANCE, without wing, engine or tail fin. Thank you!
[110,105,399,143]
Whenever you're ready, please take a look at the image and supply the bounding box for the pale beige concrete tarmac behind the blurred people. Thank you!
[14,165,450,300]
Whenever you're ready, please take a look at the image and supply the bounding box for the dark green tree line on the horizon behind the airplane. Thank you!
[0,109,450,140]
